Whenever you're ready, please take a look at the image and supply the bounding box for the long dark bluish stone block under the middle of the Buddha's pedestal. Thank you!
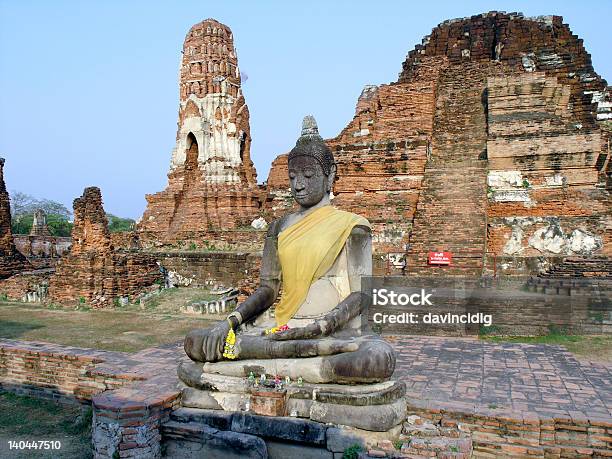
[232,413,326,445]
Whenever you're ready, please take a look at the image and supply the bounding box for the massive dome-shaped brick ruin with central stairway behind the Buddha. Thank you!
[266,12,612,275]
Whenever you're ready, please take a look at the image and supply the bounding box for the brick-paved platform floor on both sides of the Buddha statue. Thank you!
[0,336,612,418]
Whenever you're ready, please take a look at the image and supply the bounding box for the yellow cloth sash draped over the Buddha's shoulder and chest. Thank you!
[276,206,370,326]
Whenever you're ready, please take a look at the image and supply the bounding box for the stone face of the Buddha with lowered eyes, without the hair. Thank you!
[289,156,334,208]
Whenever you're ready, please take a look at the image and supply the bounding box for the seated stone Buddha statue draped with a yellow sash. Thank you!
[179,116,395,384]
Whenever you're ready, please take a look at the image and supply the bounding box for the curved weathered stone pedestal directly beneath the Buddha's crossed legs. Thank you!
[178,362,406,432]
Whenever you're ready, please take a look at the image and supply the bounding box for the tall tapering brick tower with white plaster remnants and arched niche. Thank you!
[138,19,261,243]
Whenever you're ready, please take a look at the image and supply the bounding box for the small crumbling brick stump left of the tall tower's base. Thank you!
[49,187,161,307]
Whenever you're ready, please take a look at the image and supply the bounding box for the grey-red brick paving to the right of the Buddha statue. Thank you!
[390,336,612,420]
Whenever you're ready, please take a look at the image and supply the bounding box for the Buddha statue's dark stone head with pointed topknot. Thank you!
[288,116,336,209]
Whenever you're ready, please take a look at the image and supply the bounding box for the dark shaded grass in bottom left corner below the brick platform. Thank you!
[0,391,93,458]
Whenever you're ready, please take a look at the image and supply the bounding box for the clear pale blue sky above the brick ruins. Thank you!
[0,0,612,218]
